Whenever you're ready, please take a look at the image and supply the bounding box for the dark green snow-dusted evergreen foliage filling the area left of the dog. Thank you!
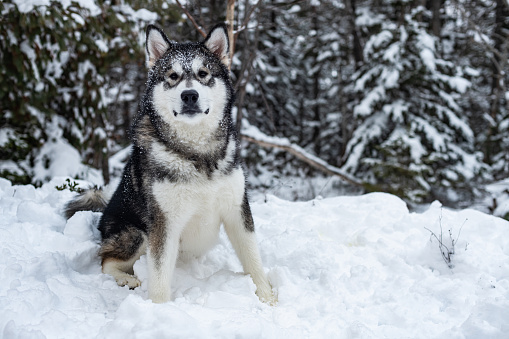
[0,1,179,184]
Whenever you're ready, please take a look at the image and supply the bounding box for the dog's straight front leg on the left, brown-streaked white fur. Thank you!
[147,229,180,303]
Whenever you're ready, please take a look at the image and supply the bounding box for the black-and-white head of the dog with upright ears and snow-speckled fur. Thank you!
[146,24,233,125]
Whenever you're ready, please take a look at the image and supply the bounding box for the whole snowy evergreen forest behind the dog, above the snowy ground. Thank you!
[0,0,509,219]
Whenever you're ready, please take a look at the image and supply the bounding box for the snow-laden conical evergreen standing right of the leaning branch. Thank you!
[343,2,482,203]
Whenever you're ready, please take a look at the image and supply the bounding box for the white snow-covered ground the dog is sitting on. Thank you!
[0,178,509,338]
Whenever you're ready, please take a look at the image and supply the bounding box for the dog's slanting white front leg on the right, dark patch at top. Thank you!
[224,195,277,304]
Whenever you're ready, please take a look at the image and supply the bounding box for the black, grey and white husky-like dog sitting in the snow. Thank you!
[65,24,276,304]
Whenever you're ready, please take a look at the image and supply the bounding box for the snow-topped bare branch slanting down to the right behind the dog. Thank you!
[241,122,365,186]
